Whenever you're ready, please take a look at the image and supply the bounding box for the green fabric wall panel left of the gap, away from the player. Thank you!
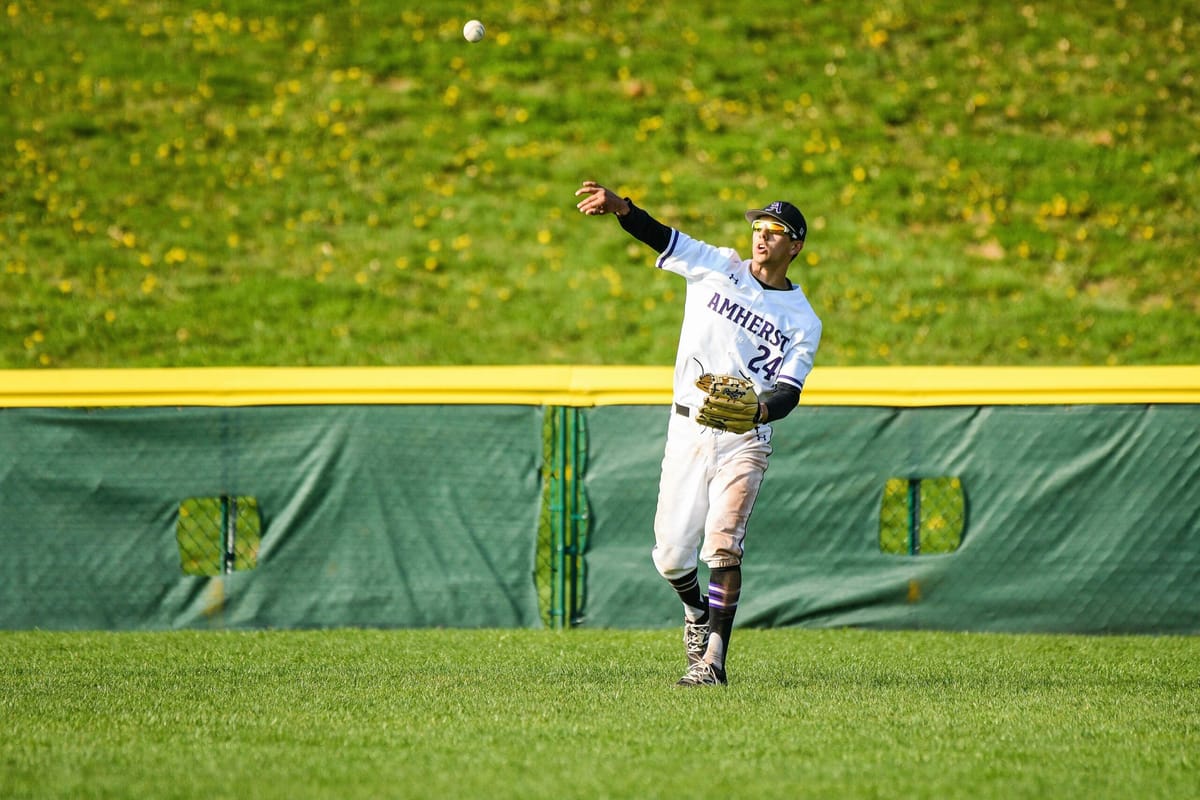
[0,405,542,630]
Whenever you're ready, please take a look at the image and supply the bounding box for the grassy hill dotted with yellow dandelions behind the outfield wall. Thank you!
[0,0,1200,368]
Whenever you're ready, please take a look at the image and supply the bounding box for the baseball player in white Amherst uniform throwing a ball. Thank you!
[575,181,821,686]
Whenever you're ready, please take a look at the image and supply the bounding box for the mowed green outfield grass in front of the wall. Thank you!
[0,630,1200,800]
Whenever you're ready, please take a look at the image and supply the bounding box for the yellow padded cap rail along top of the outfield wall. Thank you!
[0,366,1200,408]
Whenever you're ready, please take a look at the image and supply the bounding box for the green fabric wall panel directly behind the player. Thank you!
[583,405,1200,633]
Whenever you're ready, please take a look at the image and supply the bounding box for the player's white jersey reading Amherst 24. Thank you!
[656,230,821,408]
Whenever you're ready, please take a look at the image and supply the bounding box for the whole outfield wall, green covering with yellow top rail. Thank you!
[0,367,1200,633]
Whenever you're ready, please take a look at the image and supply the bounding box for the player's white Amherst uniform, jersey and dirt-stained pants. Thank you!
[653,230,821,579]
